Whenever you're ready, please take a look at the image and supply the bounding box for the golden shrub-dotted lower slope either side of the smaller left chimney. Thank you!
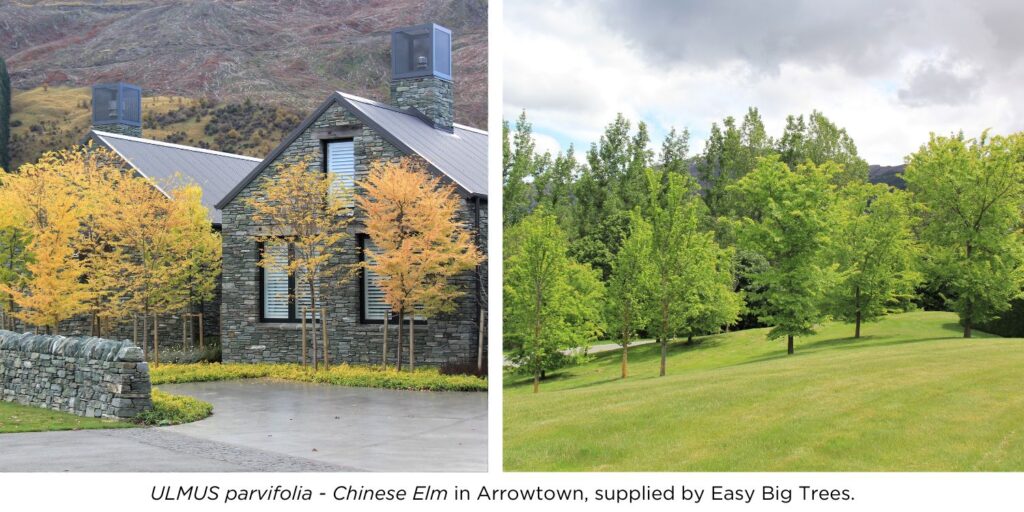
[10,87,304,168]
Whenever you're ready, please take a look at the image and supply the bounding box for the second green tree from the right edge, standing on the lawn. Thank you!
[827,182,921,338]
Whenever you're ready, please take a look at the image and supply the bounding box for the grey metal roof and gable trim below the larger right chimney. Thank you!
[216,91,487,208]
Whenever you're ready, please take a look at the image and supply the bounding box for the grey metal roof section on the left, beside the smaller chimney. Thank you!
[86,130,260,224]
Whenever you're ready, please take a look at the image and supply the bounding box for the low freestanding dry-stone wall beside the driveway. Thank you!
[0,331,153,418]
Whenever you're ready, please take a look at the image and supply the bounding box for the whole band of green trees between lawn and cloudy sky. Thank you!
[503,108,1024,389]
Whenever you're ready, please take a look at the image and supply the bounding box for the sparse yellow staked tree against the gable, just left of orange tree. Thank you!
[247,157,352,370]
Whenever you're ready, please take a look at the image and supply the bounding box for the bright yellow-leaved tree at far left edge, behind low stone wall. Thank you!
[0,153,90,334]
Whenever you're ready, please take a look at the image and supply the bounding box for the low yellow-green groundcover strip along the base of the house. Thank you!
[150,362,487,391]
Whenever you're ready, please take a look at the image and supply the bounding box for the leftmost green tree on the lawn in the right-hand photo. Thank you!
[504,208,581,393]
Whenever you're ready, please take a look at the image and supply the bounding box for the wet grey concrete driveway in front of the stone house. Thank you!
[0,380,487,471]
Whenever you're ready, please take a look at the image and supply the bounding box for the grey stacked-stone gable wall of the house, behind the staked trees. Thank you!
[220,99,486,366]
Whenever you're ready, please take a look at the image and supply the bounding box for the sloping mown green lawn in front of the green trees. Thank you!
[504,312,1024,471]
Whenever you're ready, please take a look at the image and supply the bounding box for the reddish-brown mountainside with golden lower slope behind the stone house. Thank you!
[0,0,487,166]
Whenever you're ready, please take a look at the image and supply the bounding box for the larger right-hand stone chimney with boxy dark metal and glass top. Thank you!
[391,24,455,132]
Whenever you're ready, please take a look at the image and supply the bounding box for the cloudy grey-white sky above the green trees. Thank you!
[503,0,1024,165]
